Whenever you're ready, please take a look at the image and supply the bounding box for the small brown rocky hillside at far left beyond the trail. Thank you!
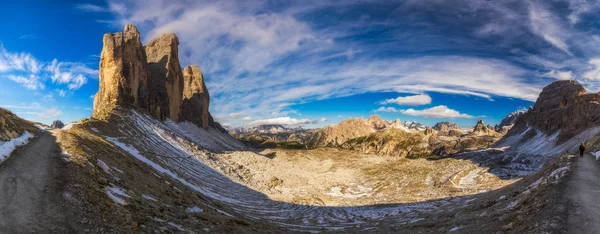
[0,108,39,141]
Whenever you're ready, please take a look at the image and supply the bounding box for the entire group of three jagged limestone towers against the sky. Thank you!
[92,24,216,131]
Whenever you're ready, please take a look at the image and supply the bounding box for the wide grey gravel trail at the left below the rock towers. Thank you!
[0,132,82,233]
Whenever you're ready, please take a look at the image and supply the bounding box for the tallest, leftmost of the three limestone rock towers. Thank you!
[92,24,148,119]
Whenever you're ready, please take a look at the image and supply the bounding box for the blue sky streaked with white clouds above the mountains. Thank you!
[0,0,600,128]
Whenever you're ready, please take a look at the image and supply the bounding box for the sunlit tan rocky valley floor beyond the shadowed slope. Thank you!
[218,148,516,206]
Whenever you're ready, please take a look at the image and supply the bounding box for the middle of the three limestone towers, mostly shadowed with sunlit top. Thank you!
[145,33,183,121]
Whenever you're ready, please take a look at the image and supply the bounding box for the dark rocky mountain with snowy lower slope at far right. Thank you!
[496,80,600,160]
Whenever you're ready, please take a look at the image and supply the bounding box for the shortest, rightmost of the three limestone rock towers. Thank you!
[181,65,212,129]
